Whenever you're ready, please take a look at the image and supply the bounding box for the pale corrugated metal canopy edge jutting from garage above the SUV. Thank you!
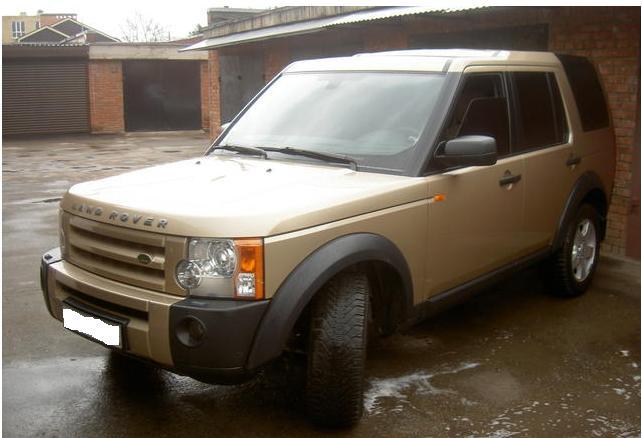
[183,3,488,50]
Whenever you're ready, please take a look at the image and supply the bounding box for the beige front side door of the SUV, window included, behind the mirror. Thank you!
[423,68,524,299]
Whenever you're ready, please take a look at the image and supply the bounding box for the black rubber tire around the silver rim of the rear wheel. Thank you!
[549,204,602,297]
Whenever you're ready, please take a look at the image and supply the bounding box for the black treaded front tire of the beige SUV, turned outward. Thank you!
[305,272,369,427]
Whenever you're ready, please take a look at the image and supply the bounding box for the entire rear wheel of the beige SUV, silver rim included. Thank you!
[551,204,600,297]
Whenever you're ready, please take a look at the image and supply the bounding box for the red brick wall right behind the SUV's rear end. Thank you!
[549,7,640,255]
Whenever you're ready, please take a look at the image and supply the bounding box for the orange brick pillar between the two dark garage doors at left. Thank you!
[88,61,125,134]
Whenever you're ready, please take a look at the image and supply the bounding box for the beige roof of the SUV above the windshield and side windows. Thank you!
[284,49,560,73]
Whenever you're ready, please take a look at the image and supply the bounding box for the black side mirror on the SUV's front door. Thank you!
[435,135,497,167]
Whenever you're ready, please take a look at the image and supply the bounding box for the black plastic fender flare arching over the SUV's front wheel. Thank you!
[247,233,413,369]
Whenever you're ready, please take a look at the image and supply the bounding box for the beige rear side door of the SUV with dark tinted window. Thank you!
[508,67,579,252]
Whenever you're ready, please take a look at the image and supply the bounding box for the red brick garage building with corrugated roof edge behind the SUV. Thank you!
[193,7,640,258]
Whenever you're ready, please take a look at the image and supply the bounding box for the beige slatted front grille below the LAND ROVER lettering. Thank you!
[62,213,185,295]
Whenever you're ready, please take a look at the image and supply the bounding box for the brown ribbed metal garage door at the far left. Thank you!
[2,60,89,134]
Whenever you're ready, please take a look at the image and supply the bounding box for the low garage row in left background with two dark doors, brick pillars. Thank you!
[2,42,210,135]
